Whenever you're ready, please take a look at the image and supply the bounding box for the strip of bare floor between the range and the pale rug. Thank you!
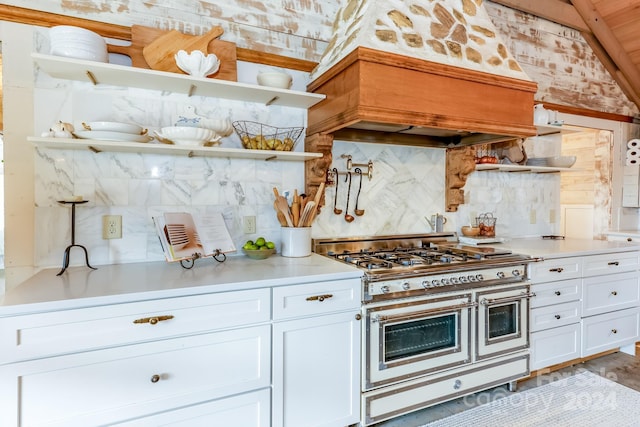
[374,353,640,427]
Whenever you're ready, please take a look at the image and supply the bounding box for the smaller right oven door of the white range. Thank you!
[476,284,534,360]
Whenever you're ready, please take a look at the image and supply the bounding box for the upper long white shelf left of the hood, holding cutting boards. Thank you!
[31,53,326,108]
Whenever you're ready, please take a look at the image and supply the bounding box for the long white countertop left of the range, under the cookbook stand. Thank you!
[0,254,362,316]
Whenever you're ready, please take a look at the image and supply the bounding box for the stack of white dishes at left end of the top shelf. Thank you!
[49,25,109,62]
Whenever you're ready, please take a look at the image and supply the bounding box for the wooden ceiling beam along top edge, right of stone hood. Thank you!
[491,0,591,32]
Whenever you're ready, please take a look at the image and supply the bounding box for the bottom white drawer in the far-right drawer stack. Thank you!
[582,308,640,357]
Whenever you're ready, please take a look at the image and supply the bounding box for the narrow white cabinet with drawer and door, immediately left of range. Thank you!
[272,279,362,427]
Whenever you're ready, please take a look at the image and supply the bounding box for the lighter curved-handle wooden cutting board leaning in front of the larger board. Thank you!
[142,27,224,73]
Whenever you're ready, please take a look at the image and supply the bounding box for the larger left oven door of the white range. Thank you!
[362,293,477,390]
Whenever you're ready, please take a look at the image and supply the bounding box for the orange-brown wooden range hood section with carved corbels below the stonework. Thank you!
[305,47,537,211]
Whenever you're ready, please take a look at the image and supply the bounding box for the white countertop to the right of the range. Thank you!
[499,237,640,258]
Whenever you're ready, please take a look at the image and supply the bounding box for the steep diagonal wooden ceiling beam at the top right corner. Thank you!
[571,0,640,112]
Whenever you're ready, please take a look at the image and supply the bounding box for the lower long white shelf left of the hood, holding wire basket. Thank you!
[27,137,322,161]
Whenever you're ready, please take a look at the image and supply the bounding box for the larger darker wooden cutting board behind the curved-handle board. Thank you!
[107,25,238,82]
